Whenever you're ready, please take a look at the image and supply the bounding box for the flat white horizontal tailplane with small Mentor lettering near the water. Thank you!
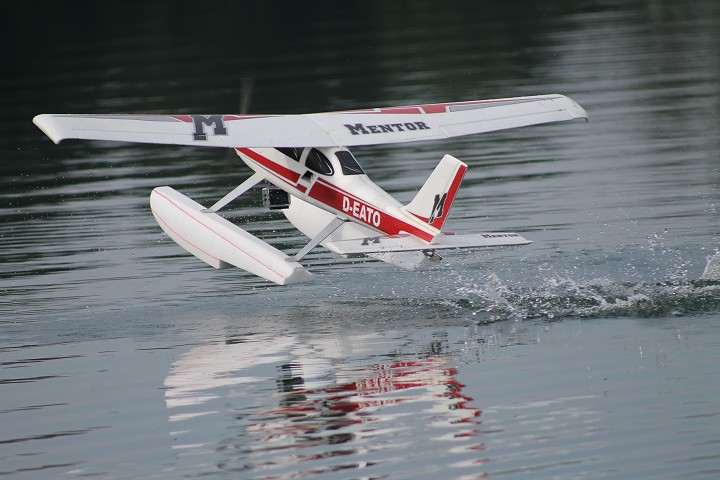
[327,232,532,257]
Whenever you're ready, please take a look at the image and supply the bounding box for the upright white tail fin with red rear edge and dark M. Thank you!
[404,155,467,230]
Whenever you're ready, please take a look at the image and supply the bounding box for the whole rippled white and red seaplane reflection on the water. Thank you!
[165,336,484,478]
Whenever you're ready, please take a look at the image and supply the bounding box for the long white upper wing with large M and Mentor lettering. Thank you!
[33,95,587,148]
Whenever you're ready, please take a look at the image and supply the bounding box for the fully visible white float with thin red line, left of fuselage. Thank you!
[150,187,313,285]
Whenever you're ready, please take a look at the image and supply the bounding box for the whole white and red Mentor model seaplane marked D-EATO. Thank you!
[33,95,587,285]
